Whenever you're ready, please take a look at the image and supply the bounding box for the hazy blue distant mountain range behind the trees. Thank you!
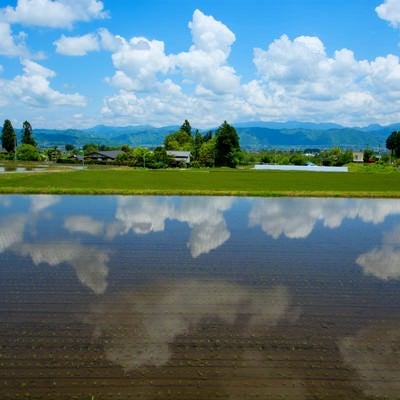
[23,121,400,149]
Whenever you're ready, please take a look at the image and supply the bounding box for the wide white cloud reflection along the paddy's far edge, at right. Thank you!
[249,199,400,239]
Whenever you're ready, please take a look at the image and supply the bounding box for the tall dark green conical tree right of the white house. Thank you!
[215,121,240,168]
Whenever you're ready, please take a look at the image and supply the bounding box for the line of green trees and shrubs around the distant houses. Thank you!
[1,119,400,168]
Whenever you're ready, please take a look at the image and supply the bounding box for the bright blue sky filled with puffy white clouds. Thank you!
[0,0,400,128]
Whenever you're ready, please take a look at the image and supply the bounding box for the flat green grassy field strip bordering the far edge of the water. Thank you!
[0,169,400,198]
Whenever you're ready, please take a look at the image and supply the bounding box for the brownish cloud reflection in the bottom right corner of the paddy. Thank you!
[339,322,400,398]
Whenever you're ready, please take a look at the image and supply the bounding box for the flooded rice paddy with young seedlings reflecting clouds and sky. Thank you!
[0,196,400,400]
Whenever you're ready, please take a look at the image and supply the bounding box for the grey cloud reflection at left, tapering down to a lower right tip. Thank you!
[18,243,108,294]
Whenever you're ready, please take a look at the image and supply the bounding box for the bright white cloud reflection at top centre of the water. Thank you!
[107,197,234,257]
